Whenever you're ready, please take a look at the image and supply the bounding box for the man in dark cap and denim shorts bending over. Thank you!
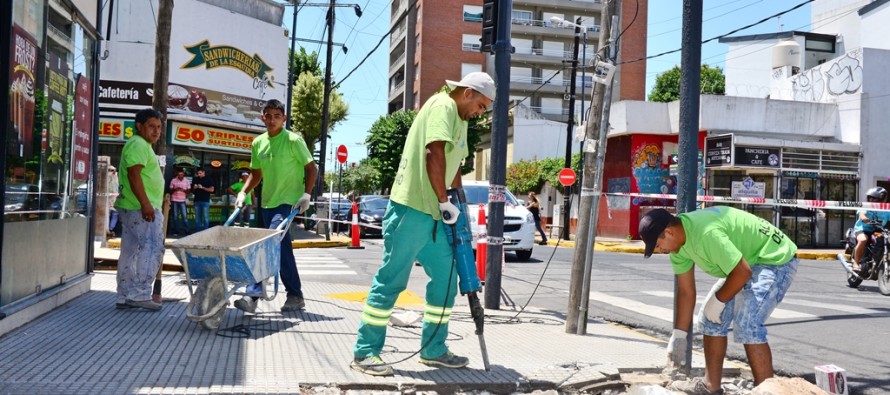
[639,206,798,394]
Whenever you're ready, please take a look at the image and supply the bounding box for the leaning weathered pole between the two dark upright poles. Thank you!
[566,0,618,334]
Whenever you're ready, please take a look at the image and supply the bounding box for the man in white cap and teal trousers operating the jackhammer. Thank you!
[351,72,495,376]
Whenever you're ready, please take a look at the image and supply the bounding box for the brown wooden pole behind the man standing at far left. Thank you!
[151,0,173,302]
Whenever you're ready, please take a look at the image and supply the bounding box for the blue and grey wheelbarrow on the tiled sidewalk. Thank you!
[170,207,299,330]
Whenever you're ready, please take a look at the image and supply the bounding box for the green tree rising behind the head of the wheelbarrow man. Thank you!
[291,72,349,152]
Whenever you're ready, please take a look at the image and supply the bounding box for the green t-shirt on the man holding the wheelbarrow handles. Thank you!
[250,129,313,208]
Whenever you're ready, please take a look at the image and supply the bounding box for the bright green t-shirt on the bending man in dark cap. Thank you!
[671,206,797,278]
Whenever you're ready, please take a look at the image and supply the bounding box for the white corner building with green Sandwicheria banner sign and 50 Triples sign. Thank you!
[99,0,289,227]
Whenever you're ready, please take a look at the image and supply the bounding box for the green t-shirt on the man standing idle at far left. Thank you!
[114,136,164,210]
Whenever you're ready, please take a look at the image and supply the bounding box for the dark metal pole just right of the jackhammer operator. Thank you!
[482,0,513,310]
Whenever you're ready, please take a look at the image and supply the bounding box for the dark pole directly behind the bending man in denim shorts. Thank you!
[674,0,702,373]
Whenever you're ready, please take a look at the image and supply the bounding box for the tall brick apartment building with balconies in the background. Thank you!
[388,0,648,121]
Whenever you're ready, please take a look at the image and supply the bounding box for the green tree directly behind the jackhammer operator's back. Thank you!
[365,110,417,194]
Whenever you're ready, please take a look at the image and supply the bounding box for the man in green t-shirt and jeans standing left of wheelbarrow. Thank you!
[115,108,164,311]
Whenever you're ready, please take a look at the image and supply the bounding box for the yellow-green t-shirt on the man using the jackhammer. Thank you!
[390,93,469,220]
